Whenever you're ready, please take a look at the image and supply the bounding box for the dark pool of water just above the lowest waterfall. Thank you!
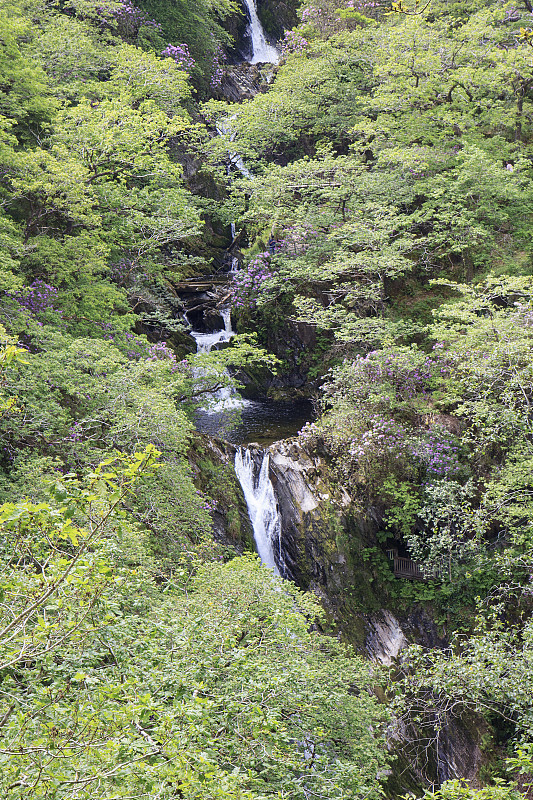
[195,400,315,447]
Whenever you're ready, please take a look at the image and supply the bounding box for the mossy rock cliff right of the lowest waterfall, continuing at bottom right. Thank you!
[262,440,491,796]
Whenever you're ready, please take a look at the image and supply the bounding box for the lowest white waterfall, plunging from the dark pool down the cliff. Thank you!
[235,447,281,575]
